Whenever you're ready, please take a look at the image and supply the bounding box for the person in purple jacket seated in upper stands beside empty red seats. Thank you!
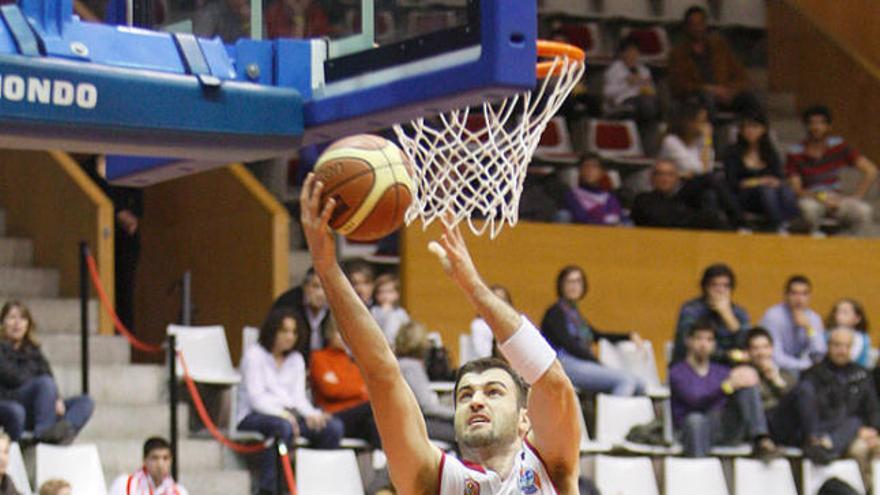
[565,154,623,225]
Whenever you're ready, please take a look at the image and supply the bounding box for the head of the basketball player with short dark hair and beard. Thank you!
[455,368,524,448]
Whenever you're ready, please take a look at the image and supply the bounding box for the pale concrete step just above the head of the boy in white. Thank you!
[77,404,189,442]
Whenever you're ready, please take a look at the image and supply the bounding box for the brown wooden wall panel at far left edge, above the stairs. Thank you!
[0,150,114,334]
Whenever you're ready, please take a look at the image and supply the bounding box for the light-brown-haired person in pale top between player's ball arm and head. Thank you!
[394,321,455,444]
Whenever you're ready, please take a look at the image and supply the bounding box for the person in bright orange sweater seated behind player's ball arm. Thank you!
[309,318,382,448]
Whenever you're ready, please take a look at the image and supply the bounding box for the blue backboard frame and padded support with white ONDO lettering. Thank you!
[0,0,537,185]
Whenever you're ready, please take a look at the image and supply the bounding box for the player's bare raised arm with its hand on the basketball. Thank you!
[300,174,442,495]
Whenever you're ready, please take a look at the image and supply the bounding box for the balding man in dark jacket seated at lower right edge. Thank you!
[796,328,880,486]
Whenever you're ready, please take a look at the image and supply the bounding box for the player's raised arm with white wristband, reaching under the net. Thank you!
[428,227,580,488]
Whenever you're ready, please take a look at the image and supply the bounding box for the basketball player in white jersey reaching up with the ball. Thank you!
[300,174,580,495]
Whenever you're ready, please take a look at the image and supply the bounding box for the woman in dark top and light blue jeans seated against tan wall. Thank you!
[541,265,645,396]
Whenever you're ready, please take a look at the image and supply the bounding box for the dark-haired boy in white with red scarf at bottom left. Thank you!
[108,437,189,495]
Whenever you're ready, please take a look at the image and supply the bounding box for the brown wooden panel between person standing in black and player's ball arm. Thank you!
[135,165,290,362]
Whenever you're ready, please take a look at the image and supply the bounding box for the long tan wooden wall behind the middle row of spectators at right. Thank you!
[402,223,880,374]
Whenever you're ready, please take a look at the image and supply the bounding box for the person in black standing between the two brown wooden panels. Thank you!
[80,155,144,338]
